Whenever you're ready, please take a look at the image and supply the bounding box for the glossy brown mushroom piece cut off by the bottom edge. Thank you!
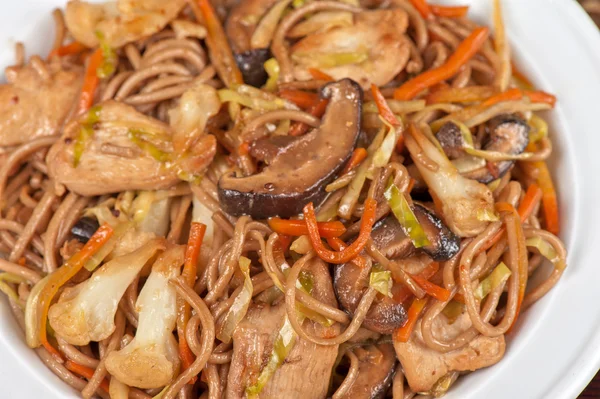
[345,344,396,399]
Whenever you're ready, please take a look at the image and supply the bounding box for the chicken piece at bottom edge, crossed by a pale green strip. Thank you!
[226,258,340,399]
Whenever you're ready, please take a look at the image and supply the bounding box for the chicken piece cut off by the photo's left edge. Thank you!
[0,58,82,146]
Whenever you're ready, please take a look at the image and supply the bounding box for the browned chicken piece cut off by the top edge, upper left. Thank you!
[65,0,186,48]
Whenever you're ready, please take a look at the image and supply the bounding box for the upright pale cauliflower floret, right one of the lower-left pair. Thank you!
[106,245,185,389]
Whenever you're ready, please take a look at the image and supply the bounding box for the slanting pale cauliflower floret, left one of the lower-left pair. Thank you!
[48,239,164,345]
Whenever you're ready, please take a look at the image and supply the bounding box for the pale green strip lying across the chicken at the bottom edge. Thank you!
[246,316,297,399]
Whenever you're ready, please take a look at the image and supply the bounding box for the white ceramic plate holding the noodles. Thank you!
[0,0,600,399]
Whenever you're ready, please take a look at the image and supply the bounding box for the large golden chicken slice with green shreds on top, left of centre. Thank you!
[46,101,216,196]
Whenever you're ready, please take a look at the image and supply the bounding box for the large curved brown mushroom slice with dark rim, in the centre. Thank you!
[218,79,362,219]
